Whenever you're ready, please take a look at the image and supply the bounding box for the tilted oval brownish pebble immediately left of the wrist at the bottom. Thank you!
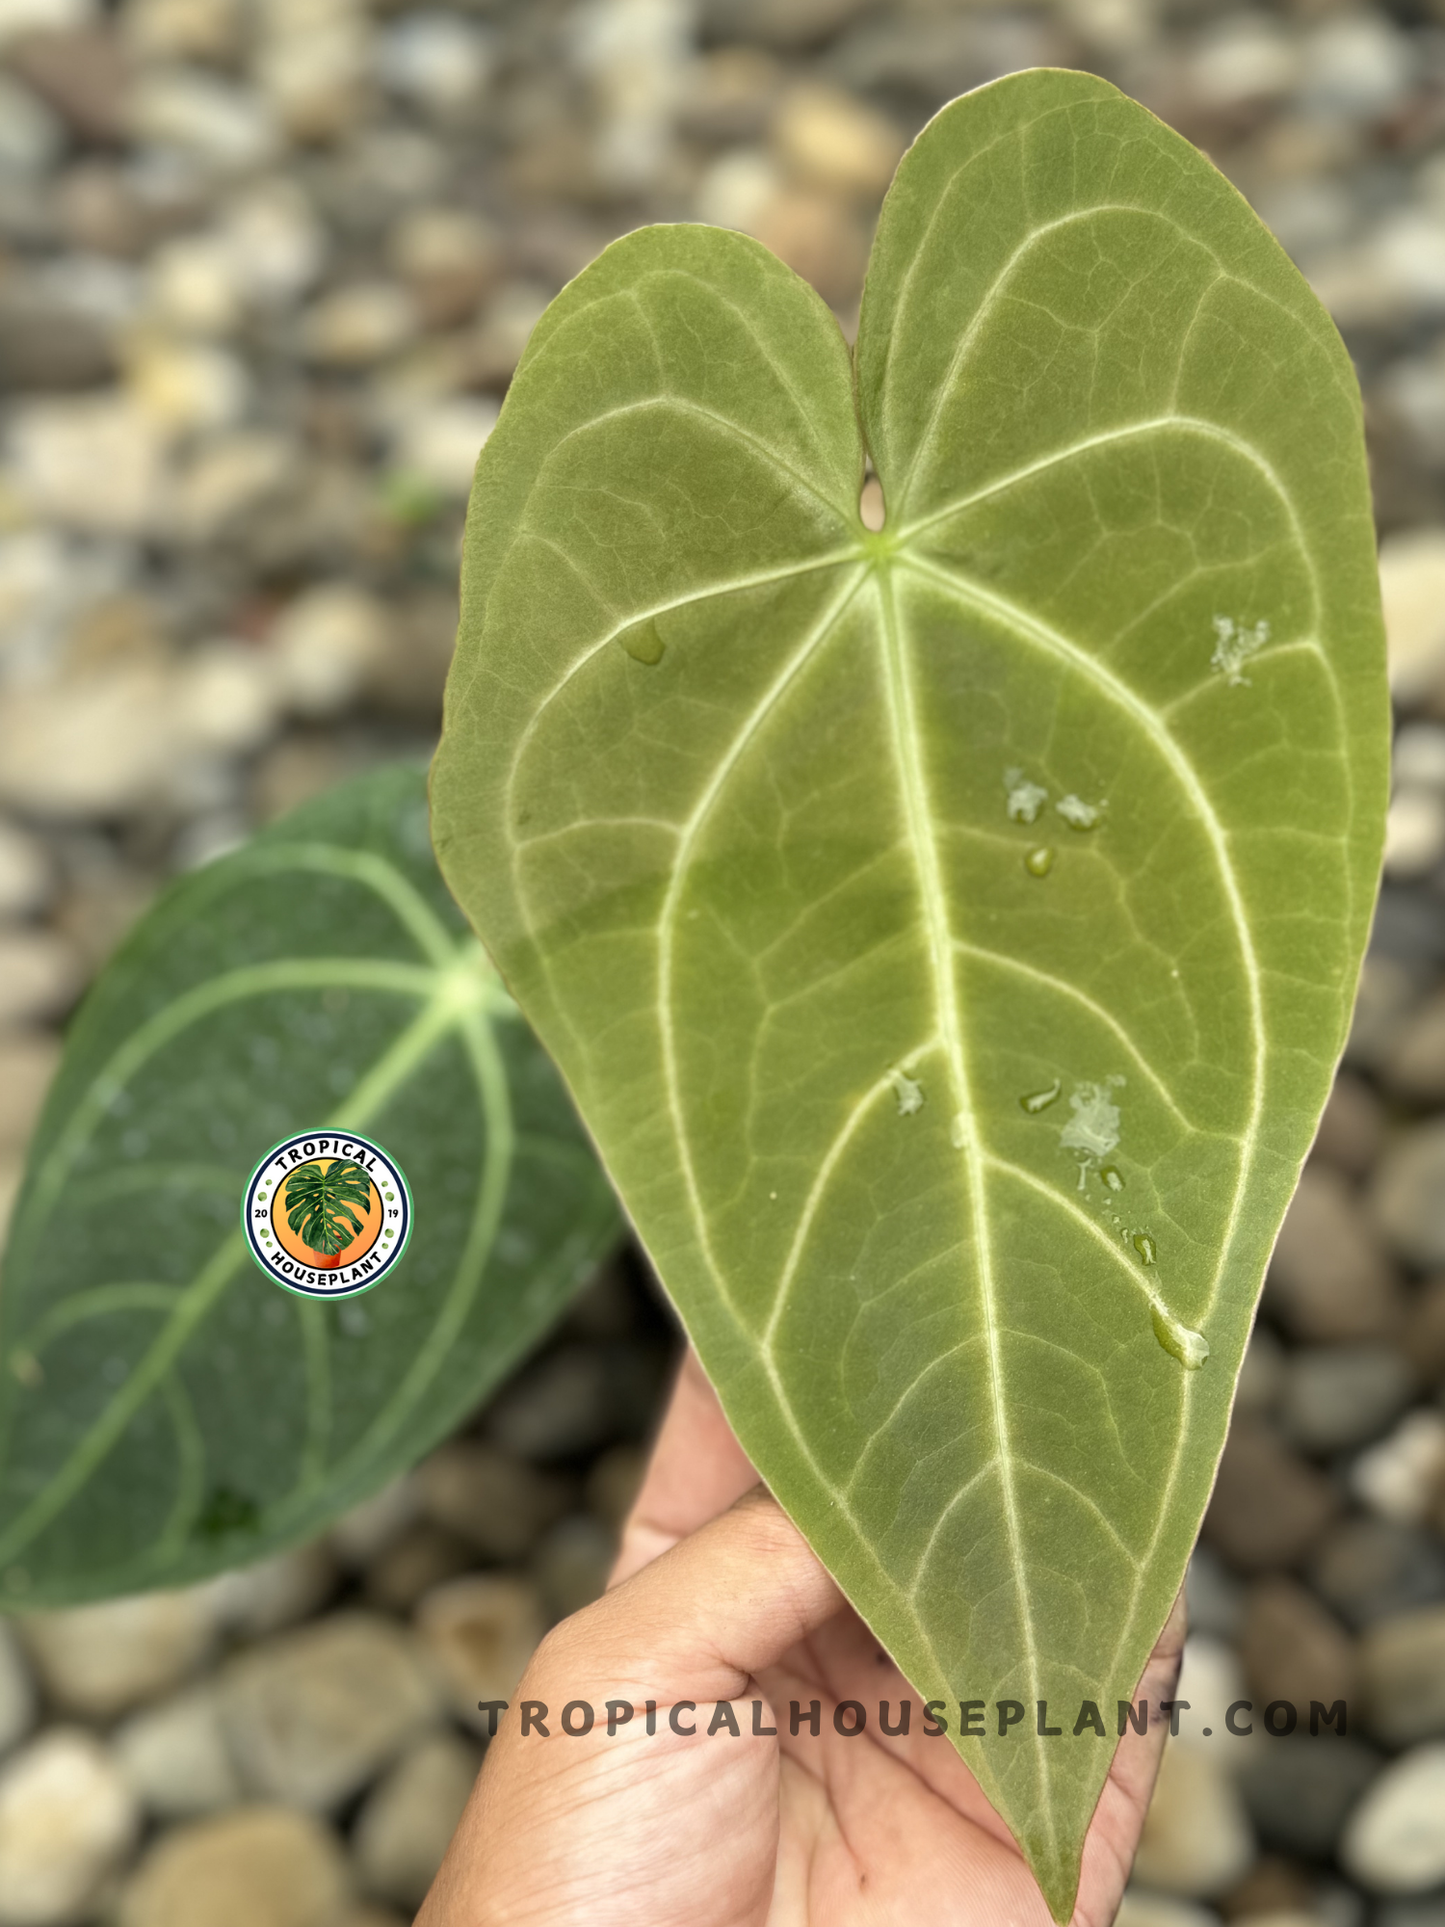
[351,1732,482,1908]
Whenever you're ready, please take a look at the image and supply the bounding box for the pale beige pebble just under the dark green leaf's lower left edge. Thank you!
[19,1588,216,1719]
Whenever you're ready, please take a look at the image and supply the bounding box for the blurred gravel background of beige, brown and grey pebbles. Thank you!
[0,0,1445,1927]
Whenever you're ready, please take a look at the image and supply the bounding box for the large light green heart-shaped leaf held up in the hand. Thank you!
[434,71,1387,1919]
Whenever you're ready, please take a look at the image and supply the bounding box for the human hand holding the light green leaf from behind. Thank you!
[416,1353,1183,1927]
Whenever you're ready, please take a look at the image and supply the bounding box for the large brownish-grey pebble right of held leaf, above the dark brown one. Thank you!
[1266,1164,1401,1343]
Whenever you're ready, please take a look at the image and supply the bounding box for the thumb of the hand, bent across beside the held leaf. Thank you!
[558,1486,844,1705]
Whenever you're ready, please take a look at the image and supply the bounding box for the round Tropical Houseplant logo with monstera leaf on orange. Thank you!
[241,1131,412,1299]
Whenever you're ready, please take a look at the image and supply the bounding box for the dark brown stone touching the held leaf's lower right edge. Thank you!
[1204,1414,1339,1572]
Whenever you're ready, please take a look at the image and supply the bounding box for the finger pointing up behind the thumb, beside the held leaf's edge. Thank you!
[609,1347,757,1586]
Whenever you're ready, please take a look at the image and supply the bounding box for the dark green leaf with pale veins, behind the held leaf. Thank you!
[0,769,617,1609]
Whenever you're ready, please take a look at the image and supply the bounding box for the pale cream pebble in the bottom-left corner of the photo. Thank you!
[0,1727,139,1927]
